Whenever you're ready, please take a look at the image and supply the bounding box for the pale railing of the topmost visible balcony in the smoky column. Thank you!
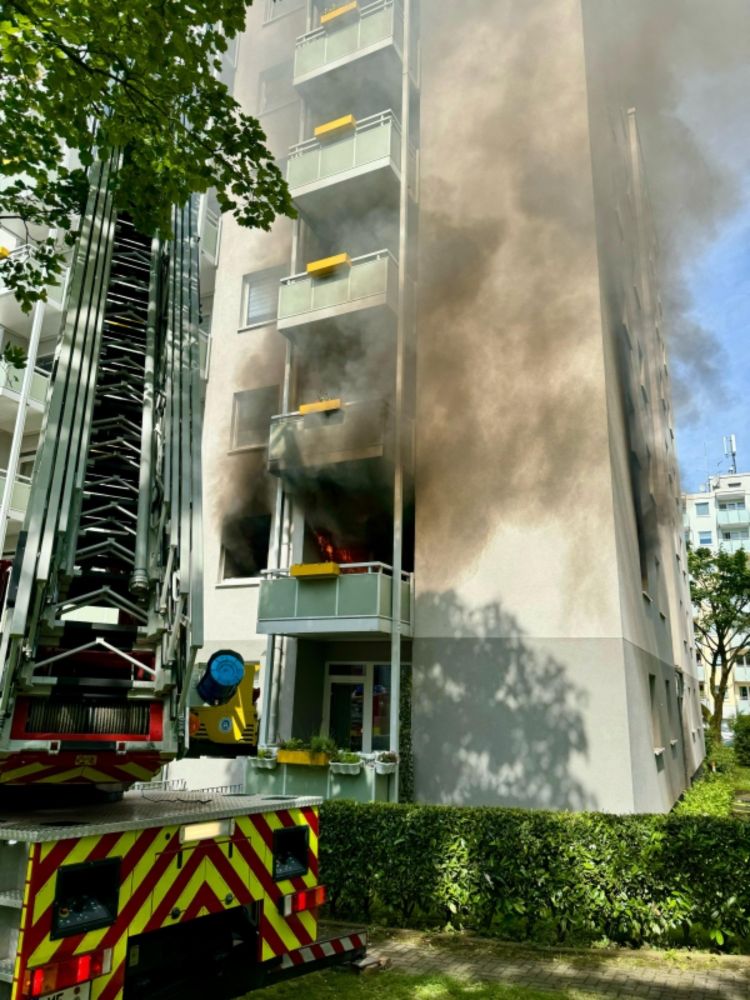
[294,0,404,84]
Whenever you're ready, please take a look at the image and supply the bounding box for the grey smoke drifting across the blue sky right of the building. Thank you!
[583,0,750,422]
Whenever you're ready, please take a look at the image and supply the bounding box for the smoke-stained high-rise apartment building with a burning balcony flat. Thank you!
[179,0,703,812]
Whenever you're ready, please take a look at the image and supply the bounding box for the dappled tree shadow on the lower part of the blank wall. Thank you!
[413,590,597,810]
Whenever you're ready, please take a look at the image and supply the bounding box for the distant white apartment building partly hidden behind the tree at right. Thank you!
[682,472,750,719]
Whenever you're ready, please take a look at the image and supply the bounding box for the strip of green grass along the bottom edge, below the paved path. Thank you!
[258,969,604,1000]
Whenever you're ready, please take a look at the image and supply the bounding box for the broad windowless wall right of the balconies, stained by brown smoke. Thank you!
[413,0,702,812]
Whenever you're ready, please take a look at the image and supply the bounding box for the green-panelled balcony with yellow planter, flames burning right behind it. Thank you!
[258,563,412,638]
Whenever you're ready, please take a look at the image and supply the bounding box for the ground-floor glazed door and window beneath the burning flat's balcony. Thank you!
[323,663,391,753]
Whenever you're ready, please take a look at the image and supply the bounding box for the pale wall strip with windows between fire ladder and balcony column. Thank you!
[200,3,305,660]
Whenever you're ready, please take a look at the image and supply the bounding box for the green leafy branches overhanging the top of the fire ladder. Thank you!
[0,0,294,310]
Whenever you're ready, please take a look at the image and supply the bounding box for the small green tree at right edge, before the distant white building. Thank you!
[688,549,750,742]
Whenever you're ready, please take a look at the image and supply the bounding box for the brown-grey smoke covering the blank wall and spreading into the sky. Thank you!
[417,0,750,584]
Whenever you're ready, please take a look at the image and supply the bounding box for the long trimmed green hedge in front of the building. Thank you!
[320,801,750,951]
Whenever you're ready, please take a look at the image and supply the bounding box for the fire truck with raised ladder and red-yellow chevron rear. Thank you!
[0,160,366,1000]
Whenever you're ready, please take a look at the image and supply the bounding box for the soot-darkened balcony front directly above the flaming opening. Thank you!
[268,399,392,478]
